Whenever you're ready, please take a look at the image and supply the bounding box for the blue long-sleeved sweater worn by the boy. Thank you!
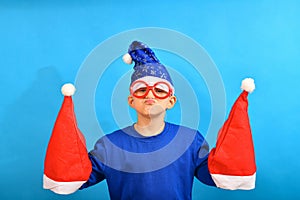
[80,123,215,200]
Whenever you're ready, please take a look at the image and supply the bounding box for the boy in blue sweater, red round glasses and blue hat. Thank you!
[81,41,215,199]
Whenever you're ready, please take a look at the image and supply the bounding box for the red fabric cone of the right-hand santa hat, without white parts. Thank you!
[208,91,256,176]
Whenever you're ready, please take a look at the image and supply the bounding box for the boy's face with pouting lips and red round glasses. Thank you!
[128,81,176,117]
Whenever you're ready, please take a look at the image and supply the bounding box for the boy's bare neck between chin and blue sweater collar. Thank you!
[134,118,165,137]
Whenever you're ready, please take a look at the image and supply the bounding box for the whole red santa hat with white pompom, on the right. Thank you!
[208,78,256,190]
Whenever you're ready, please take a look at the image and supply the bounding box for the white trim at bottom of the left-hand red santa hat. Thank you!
[43,174,86,194]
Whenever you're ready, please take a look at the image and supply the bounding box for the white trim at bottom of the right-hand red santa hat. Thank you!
[211,173,256,190]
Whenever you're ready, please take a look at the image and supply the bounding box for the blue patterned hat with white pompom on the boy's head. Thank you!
[123,41,173,87]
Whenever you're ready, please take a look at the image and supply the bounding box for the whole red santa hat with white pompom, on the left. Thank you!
[43,83,92,194]
